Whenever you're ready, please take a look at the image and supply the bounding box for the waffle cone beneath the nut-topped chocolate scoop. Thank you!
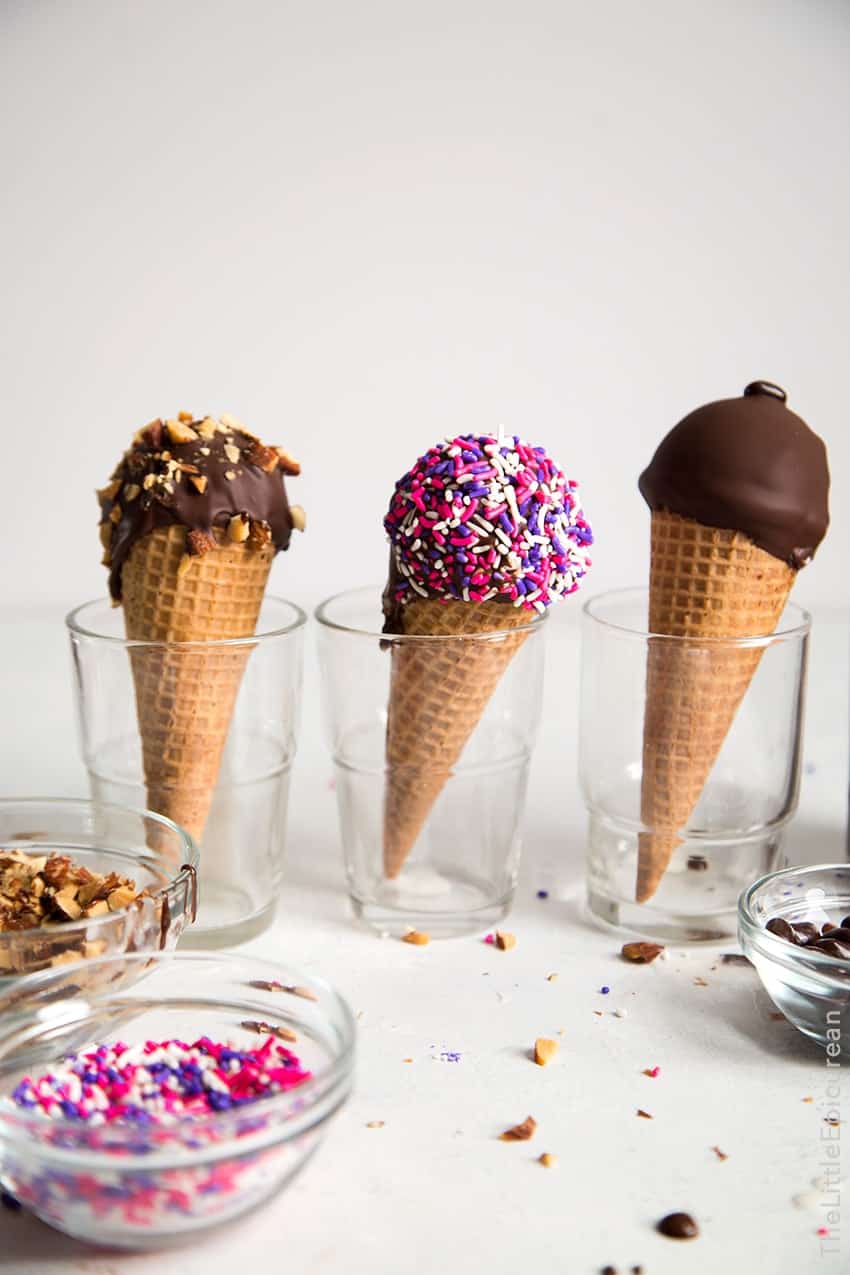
[122,527,274,840]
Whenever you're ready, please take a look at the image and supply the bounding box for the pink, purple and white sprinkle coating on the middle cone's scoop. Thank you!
[384,434,593,612]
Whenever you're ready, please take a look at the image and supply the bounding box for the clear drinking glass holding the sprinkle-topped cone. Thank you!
[316,588,545,937]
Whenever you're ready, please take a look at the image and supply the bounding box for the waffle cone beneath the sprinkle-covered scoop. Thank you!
[384,599,529,877]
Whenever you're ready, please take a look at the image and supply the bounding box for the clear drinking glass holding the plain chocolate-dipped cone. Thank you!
[580,589,810,940]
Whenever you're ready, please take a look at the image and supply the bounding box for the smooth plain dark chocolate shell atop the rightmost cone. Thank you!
[638,381,830,569]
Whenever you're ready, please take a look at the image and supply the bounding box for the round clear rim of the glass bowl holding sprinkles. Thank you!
[0,949,357,1140]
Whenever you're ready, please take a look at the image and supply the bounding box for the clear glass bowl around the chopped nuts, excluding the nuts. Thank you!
[0,798,198,988]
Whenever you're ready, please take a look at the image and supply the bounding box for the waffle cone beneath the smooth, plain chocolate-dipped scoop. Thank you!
[636,513,796,903]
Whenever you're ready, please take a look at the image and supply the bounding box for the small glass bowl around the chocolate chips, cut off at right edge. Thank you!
[738,863,850,1056]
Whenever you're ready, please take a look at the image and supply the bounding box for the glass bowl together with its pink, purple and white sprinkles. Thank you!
[0,952,354,1250]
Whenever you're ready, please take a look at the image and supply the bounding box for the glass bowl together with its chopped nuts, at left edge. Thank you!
[0,798,198,989]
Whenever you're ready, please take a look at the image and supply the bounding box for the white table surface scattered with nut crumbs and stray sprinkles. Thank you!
[0,608,850,1275]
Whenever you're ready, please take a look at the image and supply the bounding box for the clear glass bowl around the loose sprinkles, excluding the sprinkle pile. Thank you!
[0,952,356,1250]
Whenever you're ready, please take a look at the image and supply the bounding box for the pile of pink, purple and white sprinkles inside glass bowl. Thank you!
[11,1035,310,1126]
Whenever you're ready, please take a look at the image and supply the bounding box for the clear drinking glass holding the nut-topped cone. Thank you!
[66,598,307,947]
